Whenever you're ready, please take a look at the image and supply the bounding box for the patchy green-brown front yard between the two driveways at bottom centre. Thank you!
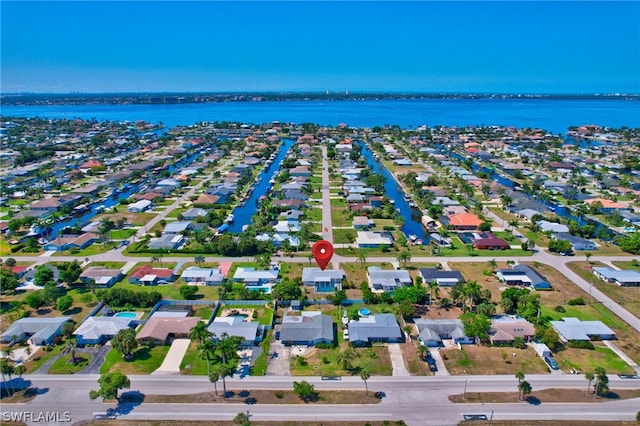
[290,343,393,376]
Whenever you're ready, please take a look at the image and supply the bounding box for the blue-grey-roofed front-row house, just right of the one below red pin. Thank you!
[349,314,404,346]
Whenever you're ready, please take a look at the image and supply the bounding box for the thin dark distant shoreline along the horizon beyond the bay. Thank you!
[0,92,640,105]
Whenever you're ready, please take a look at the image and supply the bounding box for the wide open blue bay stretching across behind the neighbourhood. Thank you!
[2,99,640,134]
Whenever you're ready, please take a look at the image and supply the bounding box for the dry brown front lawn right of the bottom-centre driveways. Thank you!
[440,345,549,375]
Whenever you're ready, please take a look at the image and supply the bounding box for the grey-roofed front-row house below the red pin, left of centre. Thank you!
[279,311,334,346]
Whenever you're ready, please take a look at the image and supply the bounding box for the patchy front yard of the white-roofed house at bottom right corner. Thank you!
[553,342,633,374]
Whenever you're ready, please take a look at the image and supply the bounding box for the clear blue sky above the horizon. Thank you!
[0,0,640,93]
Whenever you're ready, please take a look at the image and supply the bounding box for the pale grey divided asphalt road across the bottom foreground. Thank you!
[2,375,640,425]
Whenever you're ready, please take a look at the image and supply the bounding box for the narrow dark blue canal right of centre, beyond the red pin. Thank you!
[360,143,429,244]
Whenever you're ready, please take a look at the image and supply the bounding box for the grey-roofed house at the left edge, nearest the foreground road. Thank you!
[0,317,71,346]
